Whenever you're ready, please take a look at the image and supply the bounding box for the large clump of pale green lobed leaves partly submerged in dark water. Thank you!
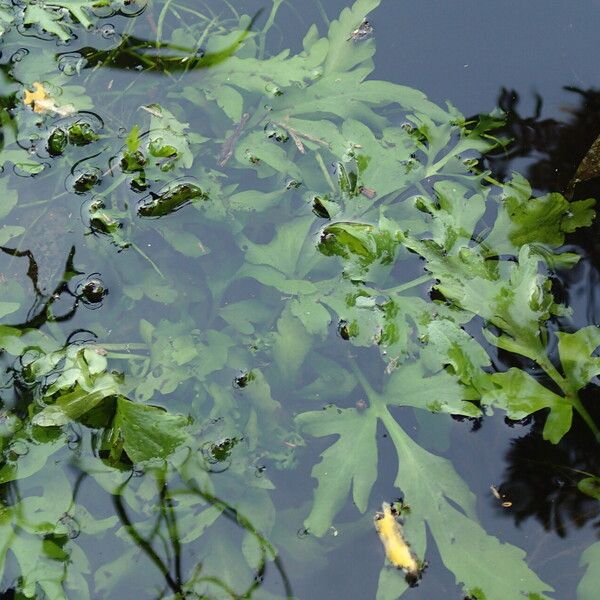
[0,0,600,600]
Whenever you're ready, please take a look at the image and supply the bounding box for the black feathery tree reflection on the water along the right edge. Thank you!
[484,87,600,536]
